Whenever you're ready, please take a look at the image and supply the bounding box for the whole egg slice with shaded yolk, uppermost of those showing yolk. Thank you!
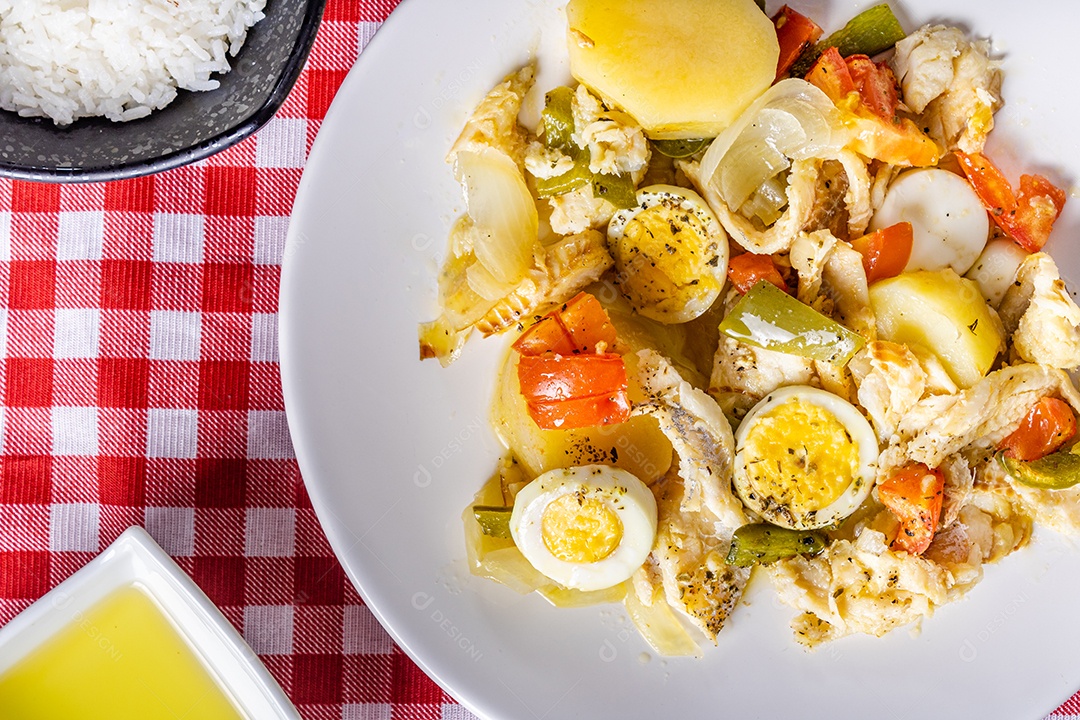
[608,185,728,325]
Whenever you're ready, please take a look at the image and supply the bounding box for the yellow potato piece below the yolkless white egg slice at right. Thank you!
[870,269,1004,388]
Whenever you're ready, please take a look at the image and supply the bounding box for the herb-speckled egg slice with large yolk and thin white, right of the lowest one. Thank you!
[734,385,878,530]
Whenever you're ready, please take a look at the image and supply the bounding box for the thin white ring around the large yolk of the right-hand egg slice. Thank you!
[733,385,878,530]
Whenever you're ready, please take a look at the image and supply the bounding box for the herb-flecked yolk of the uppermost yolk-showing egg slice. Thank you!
[621,204,713,299]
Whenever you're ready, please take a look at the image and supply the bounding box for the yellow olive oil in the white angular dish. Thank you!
[0,585,243,720]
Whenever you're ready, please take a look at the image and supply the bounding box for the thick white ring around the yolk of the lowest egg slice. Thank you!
[510,465,657,590]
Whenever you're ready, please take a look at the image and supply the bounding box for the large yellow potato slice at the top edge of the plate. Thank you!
[566,0,780,139]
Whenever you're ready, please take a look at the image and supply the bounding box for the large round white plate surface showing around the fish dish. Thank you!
[281,0,1080,720]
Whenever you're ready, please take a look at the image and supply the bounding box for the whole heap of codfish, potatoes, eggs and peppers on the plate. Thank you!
[419,0,1080,655]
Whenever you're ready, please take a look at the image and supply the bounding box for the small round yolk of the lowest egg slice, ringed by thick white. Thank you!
[540,492,622,563]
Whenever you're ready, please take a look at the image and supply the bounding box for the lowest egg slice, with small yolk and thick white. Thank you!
[510,465,657,590]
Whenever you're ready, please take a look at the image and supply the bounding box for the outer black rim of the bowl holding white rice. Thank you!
[0,0,327,182]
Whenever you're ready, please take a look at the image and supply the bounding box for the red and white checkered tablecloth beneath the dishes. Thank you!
[0,0,1080,720]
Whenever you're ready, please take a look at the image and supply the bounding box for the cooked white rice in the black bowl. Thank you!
[0,0,266,125]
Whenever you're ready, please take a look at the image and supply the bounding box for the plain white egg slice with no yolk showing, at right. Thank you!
[869,167,990,275]
